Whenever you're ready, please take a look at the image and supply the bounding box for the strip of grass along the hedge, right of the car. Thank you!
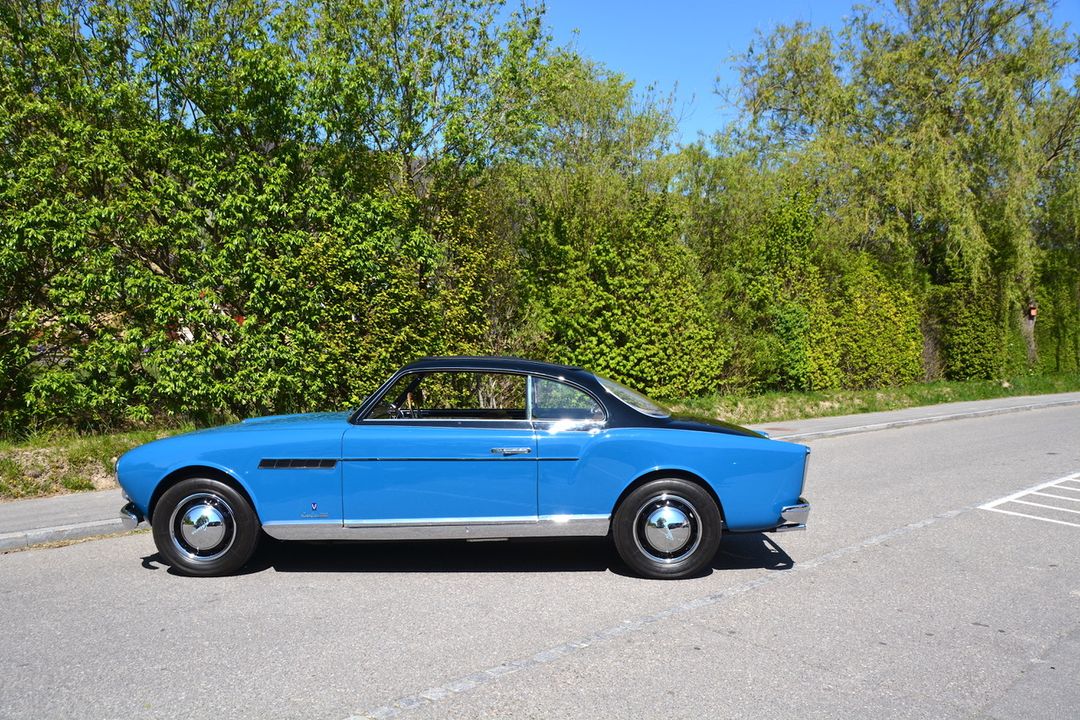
[670,375,1080,424]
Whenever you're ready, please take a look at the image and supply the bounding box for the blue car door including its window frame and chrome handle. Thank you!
[342,370,537,528]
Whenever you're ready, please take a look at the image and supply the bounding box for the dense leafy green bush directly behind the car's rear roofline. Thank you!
[516,178,728,397]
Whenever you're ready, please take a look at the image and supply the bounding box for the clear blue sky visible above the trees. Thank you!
[546,0,1080,141]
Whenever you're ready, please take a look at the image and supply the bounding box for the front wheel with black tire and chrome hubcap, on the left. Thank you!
[152,477,260,576]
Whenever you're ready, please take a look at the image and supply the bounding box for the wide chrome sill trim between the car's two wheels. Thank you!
[262,515,611,540]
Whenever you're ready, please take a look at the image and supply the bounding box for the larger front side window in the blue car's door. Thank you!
[368,371,526,420]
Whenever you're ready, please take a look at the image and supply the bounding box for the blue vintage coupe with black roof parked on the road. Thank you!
[117,357,810,578]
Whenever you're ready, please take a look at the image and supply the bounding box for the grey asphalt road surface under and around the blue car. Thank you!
[0,407,1080,720]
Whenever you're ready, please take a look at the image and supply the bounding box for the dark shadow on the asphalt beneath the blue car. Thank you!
[143,533,794,576]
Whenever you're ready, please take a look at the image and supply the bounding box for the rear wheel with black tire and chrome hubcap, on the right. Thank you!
[611,478,723,580]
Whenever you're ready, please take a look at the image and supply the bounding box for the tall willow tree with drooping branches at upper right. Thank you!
[742,0,1080,376]
